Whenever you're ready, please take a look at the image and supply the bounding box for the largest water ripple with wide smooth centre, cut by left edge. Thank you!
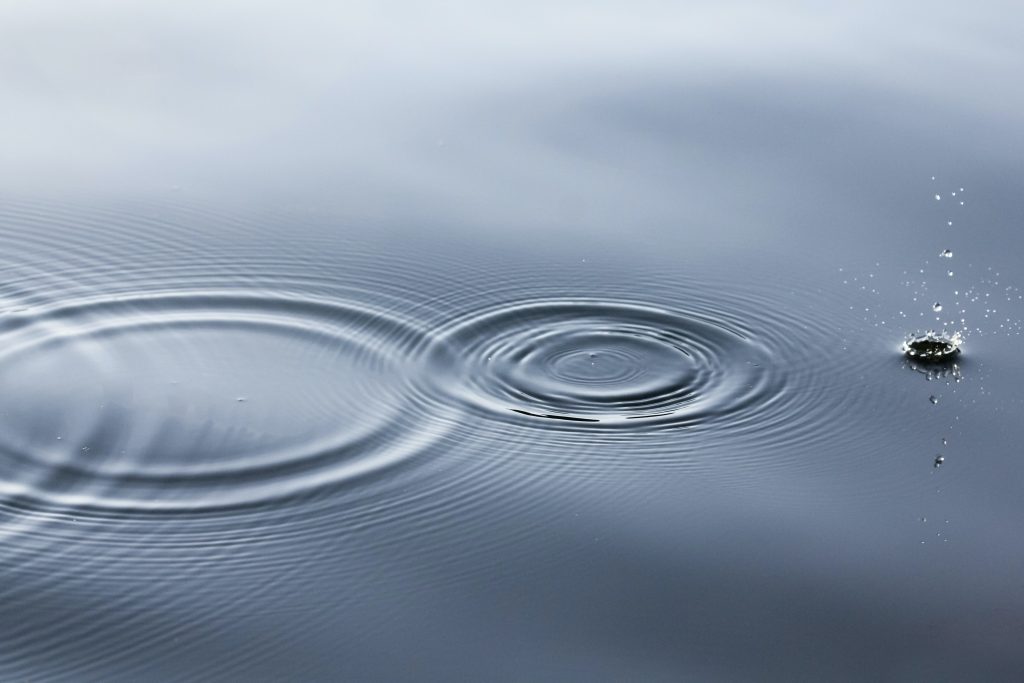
[0,292,437,512]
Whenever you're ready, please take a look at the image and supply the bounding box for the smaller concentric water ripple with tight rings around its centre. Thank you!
[421,300,770,428]
